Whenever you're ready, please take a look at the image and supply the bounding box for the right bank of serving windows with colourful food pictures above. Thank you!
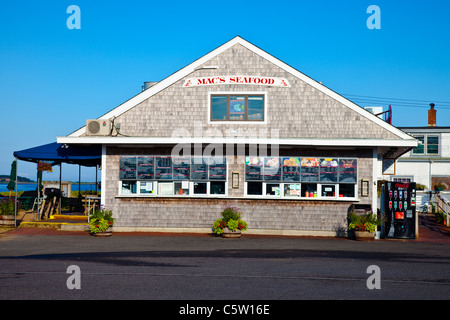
[245,157,358,199]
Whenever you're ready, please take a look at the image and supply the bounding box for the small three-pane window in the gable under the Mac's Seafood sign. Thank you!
[211,94,264,121]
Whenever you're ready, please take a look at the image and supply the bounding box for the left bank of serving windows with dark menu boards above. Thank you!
[119,156,227,196]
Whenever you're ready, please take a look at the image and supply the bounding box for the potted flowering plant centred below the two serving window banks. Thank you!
[213,206,247,238]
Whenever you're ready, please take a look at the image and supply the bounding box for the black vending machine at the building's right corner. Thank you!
[383,182,416,239]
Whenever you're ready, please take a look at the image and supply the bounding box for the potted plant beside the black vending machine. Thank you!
[348,211,381,240]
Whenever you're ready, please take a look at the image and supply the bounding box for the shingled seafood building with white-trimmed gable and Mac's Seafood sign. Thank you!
[57,37,417,236]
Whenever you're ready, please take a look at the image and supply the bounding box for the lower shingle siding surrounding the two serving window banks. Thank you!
[103,147,373,231]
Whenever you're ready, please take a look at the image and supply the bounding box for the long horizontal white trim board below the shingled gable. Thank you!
[56,136,417,148]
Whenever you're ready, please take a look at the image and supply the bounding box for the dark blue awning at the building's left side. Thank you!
[14,142,102,167]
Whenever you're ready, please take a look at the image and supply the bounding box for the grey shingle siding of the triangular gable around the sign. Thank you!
[115,44,398,139]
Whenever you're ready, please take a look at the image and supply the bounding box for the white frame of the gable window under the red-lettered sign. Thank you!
[208,91,268,124]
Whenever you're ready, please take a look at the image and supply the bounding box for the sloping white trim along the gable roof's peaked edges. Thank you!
[69,36,411,139]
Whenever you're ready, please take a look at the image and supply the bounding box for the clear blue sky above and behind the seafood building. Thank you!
[0,0,450,181]
